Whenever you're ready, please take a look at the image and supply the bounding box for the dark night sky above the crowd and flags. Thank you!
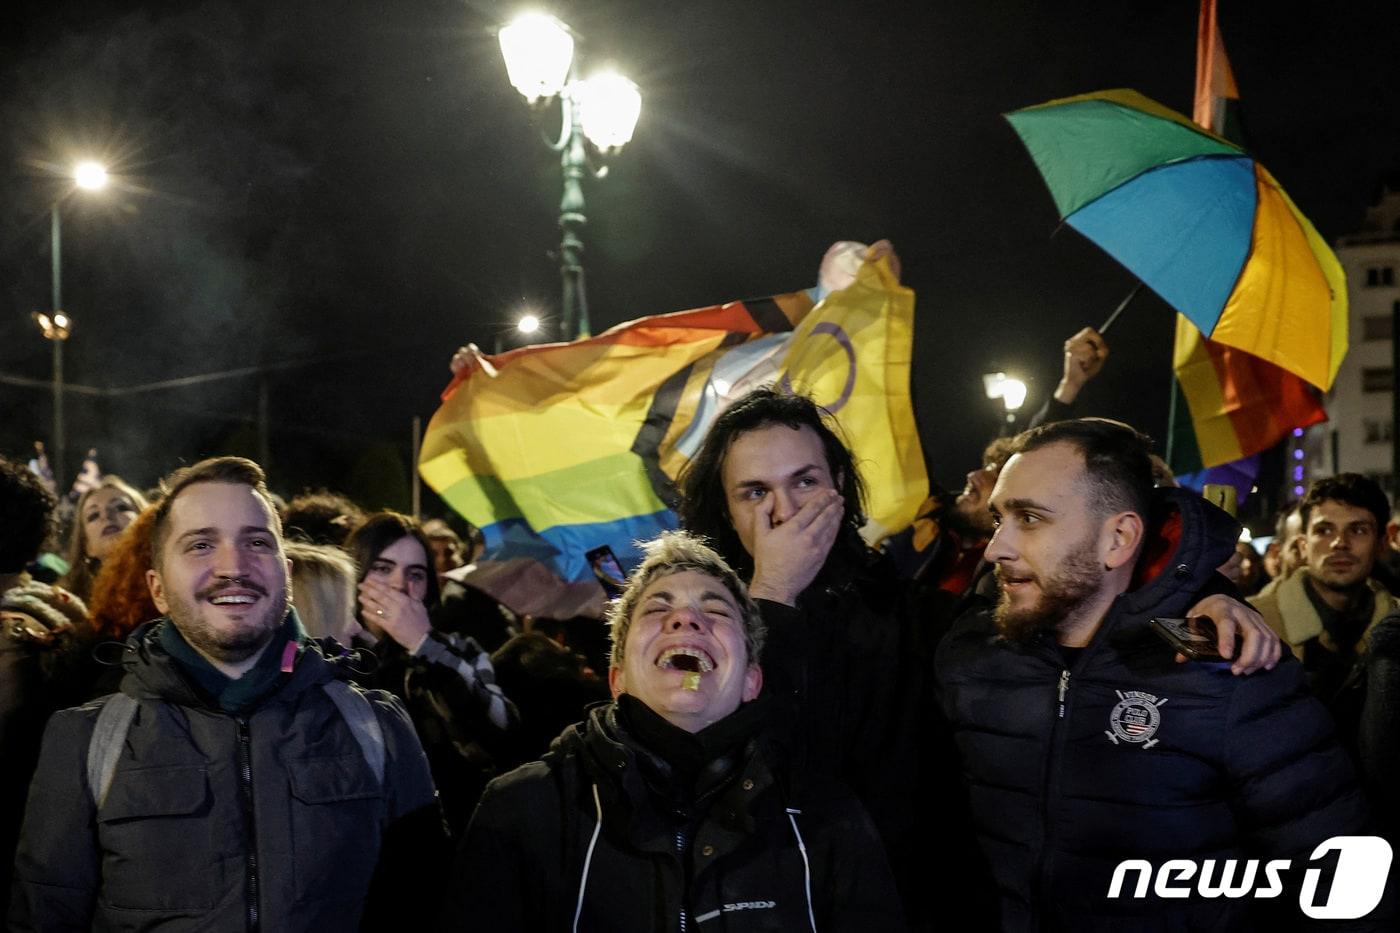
[0,0,1400,507]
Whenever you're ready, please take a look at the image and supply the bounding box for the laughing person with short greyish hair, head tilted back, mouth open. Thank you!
[444,532,903,932]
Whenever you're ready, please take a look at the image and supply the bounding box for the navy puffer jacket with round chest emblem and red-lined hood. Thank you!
[937,489,1383,933]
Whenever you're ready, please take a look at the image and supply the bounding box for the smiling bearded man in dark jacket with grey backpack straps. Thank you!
[10,457,445,933]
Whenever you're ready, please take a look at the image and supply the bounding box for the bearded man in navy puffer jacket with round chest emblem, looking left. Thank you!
[937,419,1390,933]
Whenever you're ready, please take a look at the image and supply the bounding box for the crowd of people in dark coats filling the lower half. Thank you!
[0,331,1400,932]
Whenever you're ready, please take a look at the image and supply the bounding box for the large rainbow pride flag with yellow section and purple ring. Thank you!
[419,259,928,580]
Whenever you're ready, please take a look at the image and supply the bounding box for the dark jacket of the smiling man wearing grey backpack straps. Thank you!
[10,619,442,933]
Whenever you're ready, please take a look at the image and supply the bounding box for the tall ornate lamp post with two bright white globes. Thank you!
[500,13,641,339]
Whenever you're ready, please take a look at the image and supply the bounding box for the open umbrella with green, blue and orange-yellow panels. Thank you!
[1007,90,1347,389]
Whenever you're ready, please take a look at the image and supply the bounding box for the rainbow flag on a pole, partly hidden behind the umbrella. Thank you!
[1168,0,1336,473]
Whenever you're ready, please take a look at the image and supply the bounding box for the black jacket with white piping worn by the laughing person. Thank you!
[444,703,903,933]
